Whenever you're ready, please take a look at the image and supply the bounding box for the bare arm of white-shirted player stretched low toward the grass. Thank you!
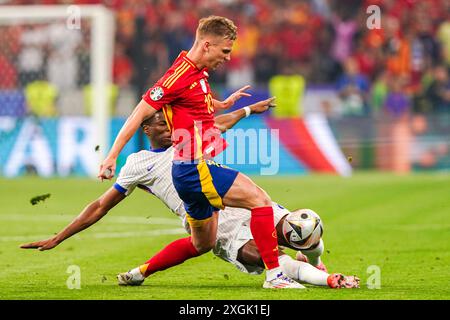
[20,188,125,251]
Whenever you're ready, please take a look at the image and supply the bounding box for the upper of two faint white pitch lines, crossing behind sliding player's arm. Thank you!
[0,214,181,225]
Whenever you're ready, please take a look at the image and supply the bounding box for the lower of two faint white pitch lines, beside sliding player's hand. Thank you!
[0,228,186,242]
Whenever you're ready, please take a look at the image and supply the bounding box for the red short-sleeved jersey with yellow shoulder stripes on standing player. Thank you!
[142,51,226,160]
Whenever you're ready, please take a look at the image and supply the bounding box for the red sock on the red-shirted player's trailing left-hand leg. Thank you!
[139,237,199,277]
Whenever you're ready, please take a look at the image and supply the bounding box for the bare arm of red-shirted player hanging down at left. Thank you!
[98,100,156,180]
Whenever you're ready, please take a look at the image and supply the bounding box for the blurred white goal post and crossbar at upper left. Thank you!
[0,5,115,175]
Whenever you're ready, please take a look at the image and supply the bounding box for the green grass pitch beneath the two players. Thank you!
[0,173,450,300]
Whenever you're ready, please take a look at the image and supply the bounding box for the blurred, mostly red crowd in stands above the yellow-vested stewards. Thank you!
[0,0,450,115]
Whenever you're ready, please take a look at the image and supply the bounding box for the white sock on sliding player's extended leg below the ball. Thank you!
[278,254,329,286]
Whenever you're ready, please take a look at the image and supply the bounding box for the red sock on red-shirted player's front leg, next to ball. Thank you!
[250,207,279,270]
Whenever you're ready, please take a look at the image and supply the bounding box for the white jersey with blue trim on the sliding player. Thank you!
[114,147,186,219]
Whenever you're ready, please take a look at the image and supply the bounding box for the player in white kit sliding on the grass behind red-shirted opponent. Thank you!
[21,99,359,288]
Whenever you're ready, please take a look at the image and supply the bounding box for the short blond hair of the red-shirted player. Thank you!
[197,16,237,40]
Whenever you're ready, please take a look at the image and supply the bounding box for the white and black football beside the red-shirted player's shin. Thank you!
[283,209,323,250]
